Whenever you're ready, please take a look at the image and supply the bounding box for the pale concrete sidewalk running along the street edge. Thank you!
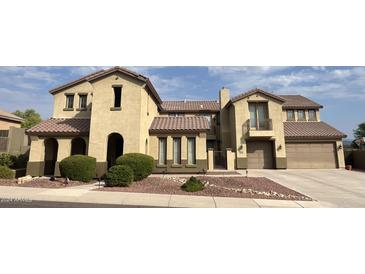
[0,185,321,208]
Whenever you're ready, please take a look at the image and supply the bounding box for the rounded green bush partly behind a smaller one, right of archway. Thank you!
[116,153,154,181]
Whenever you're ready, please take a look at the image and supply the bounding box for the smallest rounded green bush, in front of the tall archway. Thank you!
[105,165,134,187]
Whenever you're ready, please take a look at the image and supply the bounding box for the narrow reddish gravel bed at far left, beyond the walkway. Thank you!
[0,178,86,188]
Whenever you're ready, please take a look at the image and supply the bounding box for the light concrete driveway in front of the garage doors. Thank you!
[237,169,365,207]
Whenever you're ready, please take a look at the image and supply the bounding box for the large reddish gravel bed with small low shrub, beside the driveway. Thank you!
[95,176,312,201]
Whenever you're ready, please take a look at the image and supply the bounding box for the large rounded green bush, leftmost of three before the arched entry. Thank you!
[60,155,96,182]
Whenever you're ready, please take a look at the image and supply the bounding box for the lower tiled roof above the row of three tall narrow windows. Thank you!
[150,116,210,133]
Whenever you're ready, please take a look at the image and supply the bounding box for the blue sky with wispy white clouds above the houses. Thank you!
[0,67,365,138]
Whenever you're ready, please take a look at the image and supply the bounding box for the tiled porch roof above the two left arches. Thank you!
[27,118,90,136]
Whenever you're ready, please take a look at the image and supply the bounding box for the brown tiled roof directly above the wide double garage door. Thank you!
[284,122,346,139]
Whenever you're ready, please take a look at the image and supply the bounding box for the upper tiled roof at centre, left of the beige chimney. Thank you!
[161,101,220,113]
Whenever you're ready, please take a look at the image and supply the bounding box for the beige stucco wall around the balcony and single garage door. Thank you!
[231,93,286,161]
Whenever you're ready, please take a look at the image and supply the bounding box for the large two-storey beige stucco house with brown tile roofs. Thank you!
[27,67,345,176]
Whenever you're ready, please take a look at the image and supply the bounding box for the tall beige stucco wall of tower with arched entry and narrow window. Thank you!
[89,73,157,162]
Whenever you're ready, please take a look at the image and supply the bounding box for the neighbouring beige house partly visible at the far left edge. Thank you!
[0,109,28,154]
